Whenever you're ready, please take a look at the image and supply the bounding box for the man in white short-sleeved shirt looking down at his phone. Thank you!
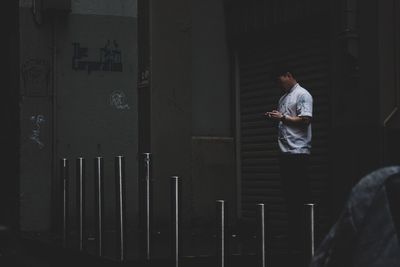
[265,67,313,266]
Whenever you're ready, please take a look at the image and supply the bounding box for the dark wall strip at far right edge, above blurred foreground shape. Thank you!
[378,0,400,168]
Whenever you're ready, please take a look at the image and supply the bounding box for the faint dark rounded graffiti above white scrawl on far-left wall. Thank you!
[21,59,50,96]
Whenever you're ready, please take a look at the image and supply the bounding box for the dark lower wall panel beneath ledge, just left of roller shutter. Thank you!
[191,137,237,228]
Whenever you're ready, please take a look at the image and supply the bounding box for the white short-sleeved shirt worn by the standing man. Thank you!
[278,83,313,154]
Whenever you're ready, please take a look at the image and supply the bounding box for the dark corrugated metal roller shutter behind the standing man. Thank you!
[239,37,330,249]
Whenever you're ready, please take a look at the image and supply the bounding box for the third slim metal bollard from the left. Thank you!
[94,157,104,257]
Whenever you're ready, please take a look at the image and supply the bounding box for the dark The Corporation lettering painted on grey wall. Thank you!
[72,40,122,74]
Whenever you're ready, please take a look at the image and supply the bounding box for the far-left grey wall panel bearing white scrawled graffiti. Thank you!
[20,8,53,231]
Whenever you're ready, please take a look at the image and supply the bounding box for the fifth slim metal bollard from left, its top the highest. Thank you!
[143,153,152,260]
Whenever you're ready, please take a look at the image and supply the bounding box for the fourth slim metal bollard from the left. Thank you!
[115,156,126,262]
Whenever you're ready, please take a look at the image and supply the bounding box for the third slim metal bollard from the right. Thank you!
[217,200,228,267]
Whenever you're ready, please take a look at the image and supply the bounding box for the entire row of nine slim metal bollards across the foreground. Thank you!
[61,153,315,267]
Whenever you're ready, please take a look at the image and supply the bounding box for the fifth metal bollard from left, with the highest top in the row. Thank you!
[142,153,153,260]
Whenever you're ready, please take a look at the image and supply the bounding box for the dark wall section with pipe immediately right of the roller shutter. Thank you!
[330,1,381,218]
